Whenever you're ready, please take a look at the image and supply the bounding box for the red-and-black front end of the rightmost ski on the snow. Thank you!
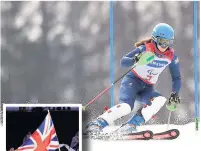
[152,129,180,140]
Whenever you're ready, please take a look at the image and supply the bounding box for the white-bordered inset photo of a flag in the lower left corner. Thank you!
[3,104,82,151]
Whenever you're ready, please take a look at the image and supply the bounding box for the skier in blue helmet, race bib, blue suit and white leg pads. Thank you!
[85,23,181,134]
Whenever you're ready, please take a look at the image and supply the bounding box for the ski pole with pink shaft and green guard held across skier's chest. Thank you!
[82,52,155,110]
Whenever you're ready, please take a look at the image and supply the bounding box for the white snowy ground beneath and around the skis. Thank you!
[83,123,201,151]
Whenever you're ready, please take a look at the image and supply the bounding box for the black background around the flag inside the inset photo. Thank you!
[6,108,79,150]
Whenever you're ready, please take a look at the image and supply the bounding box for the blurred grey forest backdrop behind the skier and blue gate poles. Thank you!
[1,1,200,124]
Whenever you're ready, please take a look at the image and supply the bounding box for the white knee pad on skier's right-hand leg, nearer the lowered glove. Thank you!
[141,96,167,122]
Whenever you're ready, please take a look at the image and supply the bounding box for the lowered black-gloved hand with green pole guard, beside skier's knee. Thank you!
[166,92,181,111]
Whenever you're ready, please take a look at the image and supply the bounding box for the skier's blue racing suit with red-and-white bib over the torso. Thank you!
[119,43,181,109]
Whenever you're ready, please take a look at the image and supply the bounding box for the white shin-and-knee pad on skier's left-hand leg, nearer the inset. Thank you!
[98,103,131,125]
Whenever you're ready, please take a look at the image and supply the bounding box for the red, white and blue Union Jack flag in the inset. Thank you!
[17,111,59,151]
